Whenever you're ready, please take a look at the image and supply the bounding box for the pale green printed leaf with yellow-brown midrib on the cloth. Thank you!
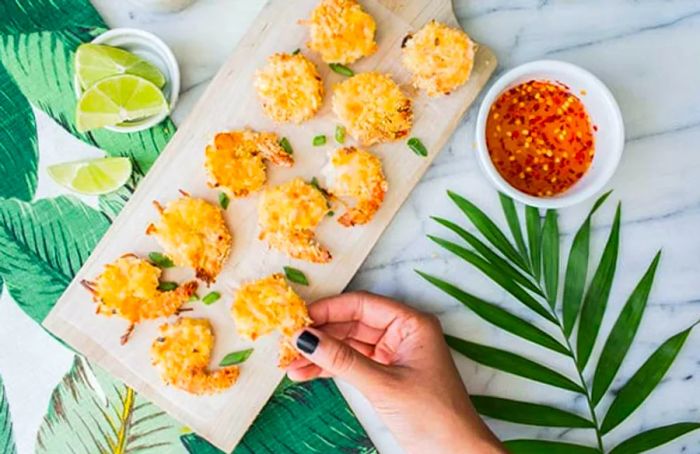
[36,356,184,454]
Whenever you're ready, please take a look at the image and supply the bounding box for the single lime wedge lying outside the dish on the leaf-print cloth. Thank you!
[46,158,131,195]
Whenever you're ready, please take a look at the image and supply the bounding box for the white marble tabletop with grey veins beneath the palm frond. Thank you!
[10,0,700,453]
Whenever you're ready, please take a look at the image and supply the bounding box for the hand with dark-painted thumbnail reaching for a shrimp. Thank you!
[287,292,505,453]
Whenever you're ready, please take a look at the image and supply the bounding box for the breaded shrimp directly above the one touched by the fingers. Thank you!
[258,178,331,263]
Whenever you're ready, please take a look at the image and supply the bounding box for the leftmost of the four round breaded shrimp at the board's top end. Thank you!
[253,53,323,124]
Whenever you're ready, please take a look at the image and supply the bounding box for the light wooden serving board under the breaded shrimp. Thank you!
[44,0,496,452]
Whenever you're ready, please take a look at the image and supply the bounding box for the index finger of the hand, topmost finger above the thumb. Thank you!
[309,292,419,329]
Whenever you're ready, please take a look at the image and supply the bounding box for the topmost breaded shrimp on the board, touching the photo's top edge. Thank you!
[301,0,377,65]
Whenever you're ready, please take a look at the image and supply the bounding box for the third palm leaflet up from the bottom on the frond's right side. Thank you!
[591,251,661,404]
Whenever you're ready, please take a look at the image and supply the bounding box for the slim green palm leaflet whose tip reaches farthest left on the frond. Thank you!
[416,270,569,355]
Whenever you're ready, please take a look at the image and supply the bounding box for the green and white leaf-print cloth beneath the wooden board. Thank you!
[0,0,376,454]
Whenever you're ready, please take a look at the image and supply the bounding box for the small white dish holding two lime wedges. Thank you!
[73,28,180,133]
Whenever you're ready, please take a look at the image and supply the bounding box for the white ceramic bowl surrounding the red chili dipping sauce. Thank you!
[476,60,625,208]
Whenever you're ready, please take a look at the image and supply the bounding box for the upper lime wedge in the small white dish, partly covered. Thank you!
[75,43,165,90]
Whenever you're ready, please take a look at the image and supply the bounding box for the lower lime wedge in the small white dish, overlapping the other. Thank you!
[76,74,168,132]
